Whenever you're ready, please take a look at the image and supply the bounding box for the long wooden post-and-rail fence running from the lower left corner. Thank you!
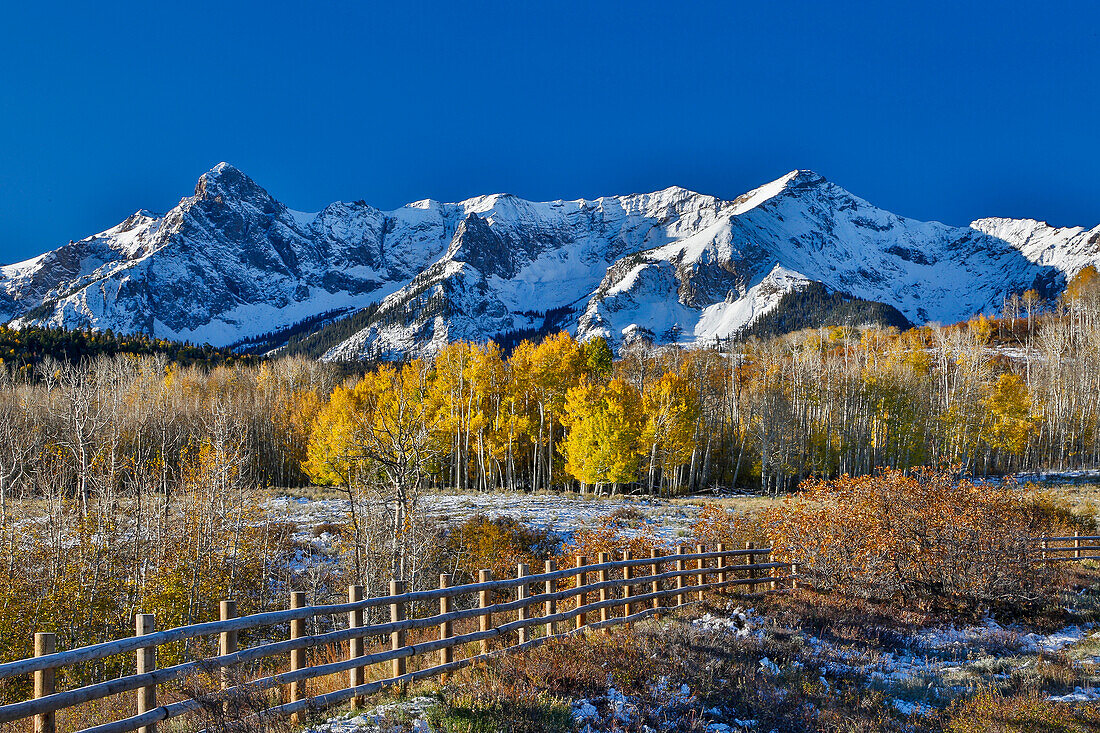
[0,538,792,733]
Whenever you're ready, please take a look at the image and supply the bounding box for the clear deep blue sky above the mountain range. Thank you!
[0,0,1100,262]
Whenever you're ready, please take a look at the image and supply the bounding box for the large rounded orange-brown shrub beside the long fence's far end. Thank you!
[768,469,1071,610]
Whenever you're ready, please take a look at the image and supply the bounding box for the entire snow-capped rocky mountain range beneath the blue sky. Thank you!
[0,163,1100,359]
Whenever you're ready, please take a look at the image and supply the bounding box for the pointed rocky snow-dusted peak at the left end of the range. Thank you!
[0,164,407,344]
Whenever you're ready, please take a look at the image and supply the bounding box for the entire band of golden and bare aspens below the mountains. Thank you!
[0,269,1100,517]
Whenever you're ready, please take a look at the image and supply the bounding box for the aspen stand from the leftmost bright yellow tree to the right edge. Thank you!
[306,269,1100,493]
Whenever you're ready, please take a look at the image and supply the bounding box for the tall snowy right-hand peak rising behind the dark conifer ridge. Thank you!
[580,171,1063,343]
